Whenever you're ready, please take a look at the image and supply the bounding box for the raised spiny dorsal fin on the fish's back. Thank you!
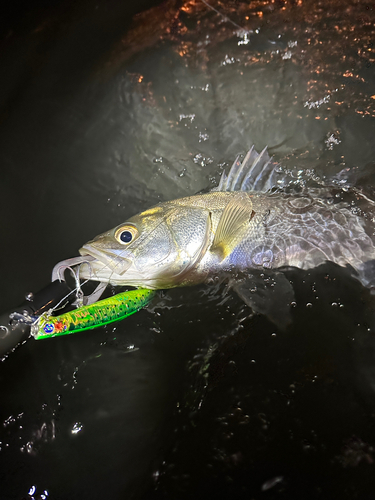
[215,146,277,193]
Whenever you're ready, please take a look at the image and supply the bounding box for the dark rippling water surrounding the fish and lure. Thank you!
[0,0,375,500]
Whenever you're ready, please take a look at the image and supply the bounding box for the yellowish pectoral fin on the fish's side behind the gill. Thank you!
[211,193,255,260]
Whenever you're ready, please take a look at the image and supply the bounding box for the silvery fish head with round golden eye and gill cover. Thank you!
[80,202,211,289]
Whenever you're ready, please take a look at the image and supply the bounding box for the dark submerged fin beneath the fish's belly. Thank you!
[233,272,294,330]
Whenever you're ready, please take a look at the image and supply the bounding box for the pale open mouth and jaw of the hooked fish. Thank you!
[79,244,131,281]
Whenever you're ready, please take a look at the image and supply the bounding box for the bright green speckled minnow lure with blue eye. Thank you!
[31,288,155,340]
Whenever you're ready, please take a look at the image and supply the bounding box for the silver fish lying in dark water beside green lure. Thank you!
[79,146,375,329]
